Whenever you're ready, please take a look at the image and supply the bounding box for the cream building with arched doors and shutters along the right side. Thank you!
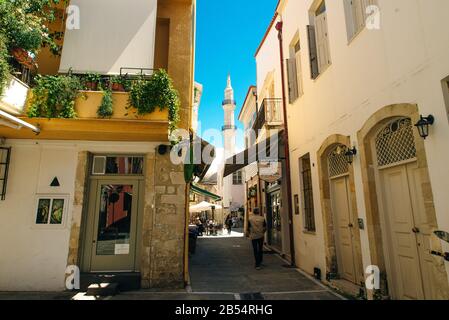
[277,0,449,299]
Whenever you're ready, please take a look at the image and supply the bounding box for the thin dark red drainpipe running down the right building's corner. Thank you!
[276,21,296,267]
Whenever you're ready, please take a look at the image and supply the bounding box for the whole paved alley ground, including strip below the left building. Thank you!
[0,230,342,300]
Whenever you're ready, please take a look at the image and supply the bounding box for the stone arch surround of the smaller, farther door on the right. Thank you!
[317,134,365,283]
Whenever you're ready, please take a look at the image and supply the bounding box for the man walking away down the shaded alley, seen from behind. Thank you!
[248,208,267,270]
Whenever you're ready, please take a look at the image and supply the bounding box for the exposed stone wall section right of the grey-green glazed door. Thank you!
[141,150,186,288]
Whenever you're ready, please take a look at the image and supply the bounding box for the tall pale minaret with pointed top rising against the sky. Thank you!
[222,75,236,159]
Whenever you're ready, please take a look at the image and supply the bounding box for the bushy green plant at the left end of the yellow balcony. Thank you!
[28,76,82,118]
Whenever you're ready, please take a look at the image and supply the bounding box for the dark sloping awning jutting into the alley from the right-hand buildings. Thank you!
[223,131,285,177]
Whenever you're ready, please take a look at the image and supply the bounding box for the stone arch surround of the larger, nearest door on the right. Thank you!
[357,103,449,299]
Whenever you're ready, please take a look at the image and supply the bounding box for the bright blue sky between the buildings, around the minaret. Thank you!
[195,0,278,148]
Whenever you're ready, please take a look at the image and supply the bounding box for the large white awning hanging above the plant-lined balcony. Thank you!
[59,0,157,74]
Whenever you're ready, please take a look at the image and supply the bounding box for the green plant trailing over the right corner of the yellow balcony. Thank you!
[128,69,181,132]
